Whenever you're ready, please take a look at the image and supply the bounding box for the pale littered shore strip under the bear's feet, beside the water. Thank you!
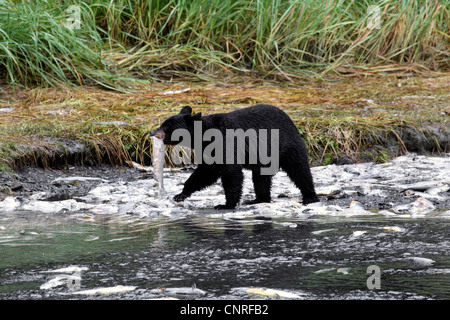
[0,154,450,218]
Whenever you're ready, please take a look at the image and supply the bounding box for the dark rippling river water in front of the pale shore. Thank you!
[0,213,450,299]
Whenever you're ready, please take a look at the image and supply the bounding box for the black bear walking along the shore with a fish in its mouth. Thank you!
[151,104,319,209]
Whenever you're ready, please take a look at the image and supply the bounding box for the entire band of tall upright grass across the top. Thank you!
[0,0,450,85]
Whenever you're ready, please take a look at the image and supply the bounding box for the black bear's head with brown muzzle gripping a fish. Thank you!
[150,106,202,145]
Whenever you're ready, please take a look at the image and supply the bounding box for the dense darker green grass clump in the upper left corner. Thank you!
[0,0,118,88]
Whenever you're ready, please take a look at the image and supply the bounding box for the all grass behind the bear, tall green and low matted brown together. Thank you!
[0,0,450,170]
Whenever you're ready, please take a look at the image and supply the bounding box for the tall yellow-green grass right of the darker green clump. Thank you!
[95,0,450,77]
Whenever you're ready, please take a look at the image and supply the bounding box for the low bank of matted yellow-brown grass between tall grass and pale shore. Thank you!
[0,74,450,171]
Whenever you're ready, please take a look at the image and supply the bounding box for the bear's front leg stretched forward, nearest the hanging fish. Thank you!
[173,164,220,202]
